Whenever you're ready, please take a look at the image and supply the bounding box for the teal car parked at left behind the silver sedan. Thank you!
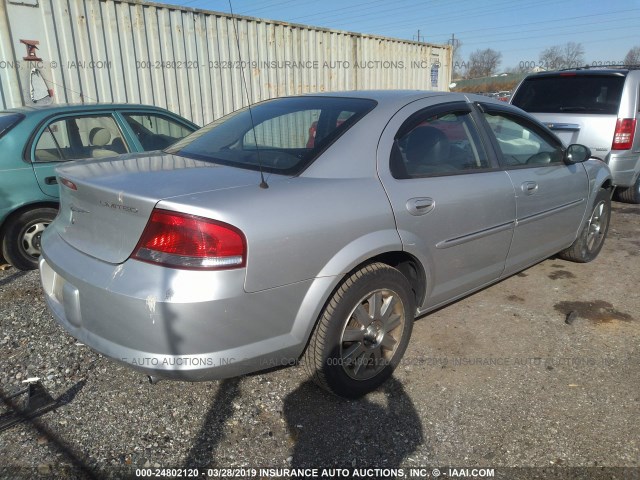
[0,104,198,270]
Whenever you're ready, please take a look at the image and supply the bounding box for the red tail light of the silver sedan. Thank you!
[132,209,247,270]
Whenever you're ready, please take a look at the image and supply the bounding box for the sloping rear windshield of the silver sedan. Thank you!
[165,97,376,175]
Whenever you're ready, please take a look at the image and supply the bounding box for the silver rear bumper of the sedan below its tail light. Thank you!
[40,229,313,381]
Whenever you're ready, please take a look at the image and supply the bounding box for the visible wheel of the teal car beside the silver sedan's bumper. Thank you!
[2,208,58,270]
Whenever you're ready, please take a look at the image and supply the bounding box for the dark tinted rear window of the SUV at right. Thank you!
[511,75,625,115]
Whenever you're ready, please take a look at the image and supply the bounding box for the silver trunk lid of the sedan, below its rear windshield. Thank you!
[53,153,259,264]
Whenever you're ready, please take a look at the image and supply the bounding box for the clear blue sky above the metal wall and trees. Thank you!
[166,0,640,70]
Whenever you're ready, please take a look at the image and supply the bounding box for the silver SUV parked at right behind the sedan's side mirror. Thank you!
[511,67,640,203]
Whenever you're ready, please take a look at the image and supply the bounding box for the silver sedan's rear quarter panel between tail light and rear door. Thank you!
[158,176,401,292]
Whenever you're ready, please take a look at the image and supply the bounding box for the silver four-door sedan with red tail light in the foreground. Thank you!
[40,91,612,397]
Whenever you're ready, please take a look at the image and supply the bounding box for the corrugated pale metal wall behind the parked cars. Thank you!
[0,0,451,125]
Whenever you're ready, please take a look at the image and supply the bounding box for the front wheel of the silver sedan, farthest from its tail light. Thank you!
[558,188,611,263]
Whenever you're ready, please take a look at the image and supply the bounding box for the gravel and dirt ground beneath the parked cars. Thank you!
[0,203,640,479]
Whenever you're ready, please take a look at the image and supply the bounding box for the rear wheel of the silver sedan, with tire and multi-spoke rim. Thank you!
[304,263,415,398]
